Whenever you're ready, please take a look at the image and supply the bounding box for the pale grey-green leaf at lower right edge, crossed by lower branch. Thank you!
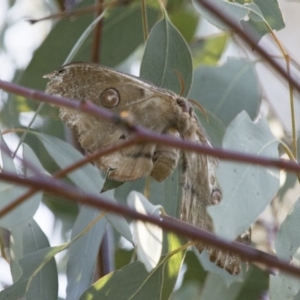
[270,199,300,300]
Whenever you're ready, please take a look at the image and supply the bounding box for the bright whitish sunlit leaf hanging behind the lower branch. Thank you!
[127,192,163,272]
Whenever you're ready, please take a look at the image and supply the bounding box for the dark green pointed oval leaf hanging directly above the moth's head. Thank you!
[140,17,192,95]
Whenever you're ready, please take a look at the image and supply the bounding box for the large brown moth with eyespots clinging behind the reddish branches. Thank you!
[45,63,250,274]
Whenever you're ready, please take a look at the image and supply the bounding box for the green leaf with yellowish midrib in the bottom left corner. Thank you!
[0,245,65,300]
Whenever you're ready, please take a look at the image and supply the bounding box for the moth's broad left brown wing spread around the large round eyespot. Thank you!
[45,63,177,181]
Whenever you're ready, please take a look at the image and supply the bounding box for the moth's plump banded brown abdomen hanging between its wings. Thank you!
[150,128,180,182]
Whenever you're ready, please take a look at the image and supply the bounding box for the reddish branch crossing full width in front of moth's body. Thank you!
[0,80,300,173]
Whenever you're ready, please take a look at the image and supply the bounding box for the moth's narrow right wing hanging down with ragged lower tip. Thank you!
[181,113,251,275]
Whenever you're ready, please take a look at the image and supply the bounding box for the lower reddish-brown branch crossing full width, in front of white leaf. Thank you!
[0,172,300,277]
